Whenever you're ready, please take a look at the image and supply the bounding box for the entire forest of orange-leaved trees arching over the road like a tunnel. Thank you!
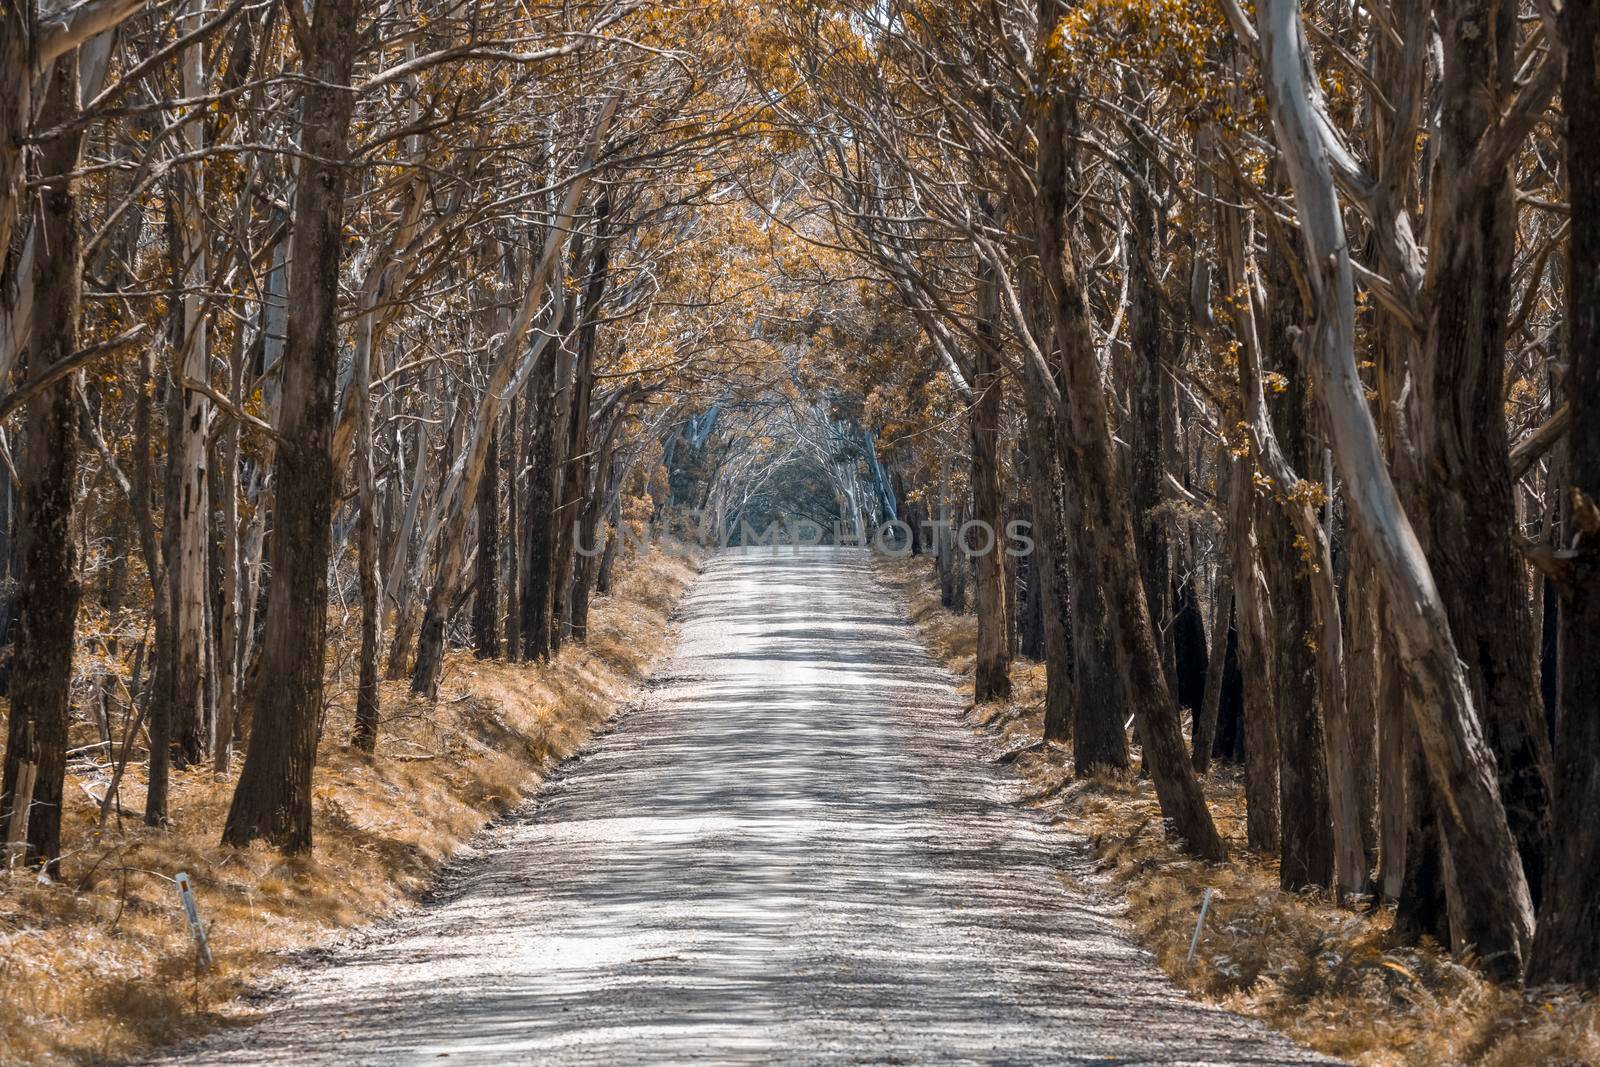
[0,0,1600,982]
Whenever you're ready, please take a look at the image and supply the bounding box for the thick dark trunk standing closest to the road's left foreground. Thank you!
[222,0,360,853]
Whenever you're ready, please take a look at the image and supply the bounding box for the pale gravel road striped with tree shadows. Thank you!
[168,549,1337,1064]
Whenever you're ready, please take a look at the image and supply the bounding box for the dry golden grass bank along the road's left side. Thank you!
[0,555,694,1064]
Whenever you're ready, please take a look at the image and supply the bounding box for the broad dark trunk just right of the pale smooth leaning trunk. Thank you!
[1411,0,1550,933]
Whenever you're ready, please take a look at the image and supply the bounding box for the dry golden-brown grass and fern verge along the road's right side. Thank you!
[882,558,1600,1067]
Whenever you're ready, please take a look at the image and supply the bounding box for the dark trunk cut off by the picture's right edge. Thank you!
[1528,0,1600,989]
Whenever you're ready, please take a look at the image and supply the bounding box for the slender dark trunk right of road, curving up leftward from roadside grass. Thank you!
[1037,20,1227,859]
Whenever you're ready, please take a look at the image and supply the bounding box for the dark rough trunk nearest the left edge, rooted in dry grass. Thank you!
[0,54,83,877]
